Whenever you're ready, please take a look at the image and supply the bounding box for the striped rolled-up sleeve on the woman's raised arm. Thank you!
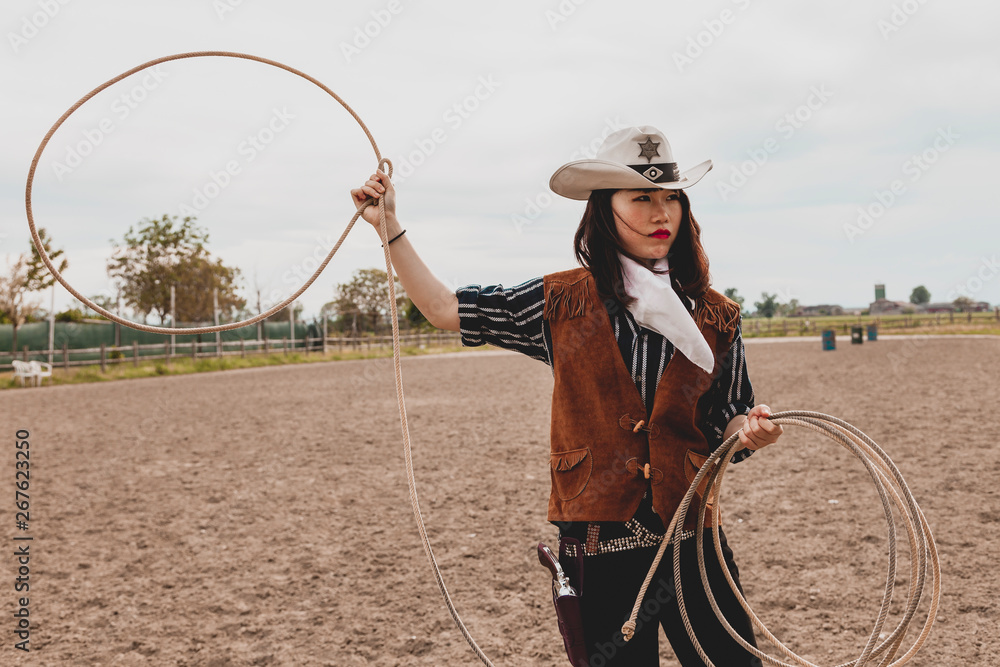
[455,278,552,365]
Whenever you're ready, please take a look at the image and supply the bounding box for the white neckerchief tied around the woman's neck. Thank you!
[618,254,715,373]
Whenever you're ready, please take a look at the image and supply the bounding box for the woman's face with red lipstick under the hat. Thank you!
[611,188,683,263]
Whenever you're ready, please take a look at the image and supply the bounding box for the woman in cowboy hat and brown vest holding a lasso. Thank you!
[351,126,781,667]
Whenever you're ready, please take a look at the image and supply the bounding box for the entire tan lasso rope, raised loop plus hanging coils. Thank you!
[25,51,940,667]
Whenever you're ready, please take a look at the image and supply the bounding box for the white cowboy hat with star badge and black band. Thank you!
[549,125,712,199]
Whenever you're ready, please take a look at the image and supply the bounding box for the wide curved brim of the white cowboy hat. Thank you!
[549,160,712,200]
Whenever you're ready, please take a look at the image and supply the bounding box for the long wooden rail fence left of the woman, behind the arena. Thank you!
[0,331,462,372]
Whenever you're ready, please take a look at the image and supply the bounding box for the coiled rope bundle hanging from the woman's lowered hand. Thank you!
[622,410,941,667]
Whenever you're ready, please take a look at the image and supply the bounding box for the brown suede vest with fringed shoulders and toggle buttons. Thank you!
[543,268,740,530]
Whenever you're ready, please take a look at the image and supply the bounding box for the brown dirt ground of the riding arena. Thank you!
[0,338,1000,667]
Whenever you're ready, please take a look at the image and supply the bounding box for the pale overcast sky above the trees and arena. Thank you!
[0,0,1000,324]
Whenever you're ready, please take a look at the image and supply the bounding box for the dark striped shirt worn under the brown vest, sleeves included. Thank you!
[456,278,754,555]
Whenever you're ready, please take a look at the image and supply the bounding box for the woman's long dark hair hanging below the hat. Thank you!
[573,190,712,306]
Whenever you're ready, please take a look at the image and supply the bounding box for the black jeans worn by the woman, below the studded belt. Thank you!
[582,530,762,667]
